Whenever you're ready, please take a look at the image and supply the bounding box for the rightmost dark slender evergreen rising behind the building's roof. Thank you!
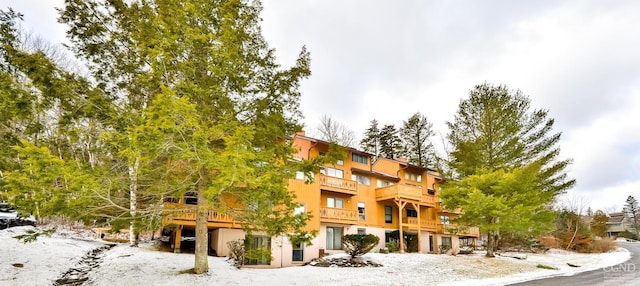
[400,112,435,168]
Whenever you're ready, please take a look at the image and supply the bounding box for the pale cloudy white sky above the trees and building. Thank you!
[0,0,640,212]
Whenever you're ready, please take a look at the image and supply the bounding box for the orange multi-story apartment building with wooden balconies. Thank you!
[163,133,479,267]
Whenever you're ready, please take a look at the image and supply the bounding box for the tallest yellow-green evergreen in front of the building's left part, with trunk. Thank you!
[61,0,310,273]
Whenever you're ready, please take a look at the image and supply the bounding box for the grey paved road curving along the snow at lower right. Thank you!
[512,242,640,286]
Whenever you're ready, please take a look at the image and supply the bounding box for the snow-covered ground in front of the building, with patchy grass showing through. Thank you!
[0,227,630,286]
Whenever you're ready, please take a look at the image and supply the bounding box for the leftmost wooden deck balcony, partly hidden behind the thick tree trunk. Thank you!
[162,202,235,225]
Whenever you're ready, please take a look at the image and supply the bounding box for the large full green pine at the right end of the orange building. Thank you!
[440,83,575,256]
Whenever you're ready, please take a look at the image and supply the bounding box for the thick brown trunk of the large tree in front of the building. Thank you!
[193,171,209,274]
